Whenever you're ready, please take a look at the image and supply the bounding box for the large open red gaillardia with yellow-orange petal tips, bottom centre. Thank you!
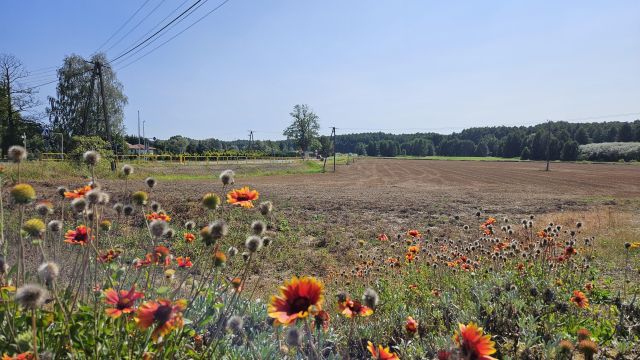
[268,276,324,325]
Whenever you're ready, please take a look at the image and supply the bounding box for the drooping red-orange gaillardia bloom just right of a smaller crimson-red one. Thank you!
[135,299,187,340]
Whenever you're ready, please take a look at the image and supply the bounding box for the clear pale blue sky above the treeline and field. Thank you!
[0,0,640,139]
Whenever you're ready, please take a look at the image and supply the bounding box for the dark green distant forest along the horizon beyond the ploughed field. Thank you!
[139,120,640,161]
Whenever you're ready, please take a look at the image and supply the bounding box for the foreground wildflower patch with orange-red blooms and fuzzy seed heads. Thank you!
[0,146,640,360]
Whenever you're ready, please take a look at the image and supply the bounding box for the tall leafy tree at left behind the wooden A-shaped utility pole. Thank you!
[47,53,128,143]
